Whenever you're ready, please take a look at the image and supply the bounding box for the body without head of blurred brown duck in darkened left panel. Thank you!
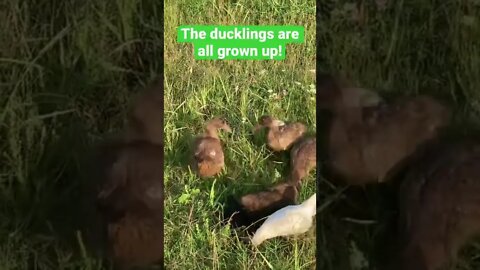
[97,142,163,269]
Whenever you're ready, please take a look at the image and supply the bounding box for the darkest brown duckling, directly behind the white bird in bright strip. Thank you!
[224,182,299,234]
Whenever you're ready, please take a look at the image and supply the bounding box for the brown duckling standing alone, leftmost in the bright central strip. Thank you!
[193,117,232,177]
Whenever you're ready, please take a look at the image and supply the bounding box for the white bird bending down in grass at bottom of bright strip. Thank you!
[252,193,317,246]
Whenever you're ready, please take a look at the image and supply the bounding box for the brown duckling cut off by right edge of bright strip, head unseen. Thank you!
[290,137,317,184]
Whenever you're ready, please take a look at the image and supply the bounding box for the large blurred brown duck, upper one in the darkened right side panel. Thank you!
[320,75,450,185]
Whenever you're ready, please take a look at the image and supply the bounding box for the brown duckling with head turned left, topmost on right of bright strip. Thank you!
[254,115,307,151]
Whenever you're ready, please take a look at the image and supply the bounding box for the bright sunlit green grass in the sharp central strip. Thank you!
[165,0,316,269]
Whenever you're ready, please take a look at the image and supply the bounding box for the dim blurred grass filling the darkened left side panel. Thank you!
[0,0,163,269]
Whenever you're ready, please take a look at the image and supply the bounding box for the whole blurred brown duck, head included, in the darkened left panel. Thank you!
[97,80,164,269]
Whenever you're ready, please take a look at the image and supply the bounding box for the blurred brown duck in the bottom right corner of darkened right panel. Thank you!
[392,142,480,270]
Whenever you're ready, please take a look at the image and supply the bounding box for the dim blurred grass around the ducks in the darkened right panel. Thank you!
[317,0,480,270]
